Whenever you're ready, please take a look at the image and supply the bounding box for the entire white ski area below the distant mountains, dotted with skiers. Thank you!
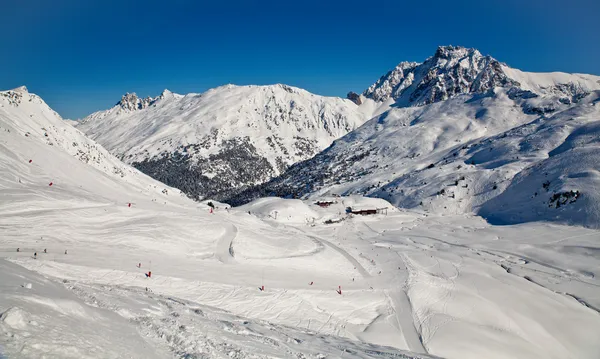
[0,90,600,358]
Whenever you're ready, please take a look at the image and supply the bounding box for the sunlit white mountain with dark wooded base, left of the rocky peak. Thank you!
[77,85,376,198]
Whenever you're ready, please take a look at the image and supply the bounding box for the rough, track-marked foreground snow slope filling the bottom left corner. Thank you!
[0,259,440,359]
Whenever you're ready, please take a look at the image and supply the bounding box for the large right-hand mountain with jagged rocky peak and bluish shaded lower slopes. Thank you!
[229,47,600,227]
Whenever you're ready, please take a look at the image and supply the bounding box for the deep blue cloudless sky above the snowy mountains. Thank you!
[0,0,600,118]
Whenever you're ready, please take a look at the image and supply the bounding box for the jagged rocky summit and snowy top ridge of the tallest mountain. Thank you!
[363,46,600,106]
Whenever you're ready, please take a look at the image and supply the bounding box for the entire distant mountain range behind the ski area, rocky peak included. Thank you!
[30,46,600,227]
